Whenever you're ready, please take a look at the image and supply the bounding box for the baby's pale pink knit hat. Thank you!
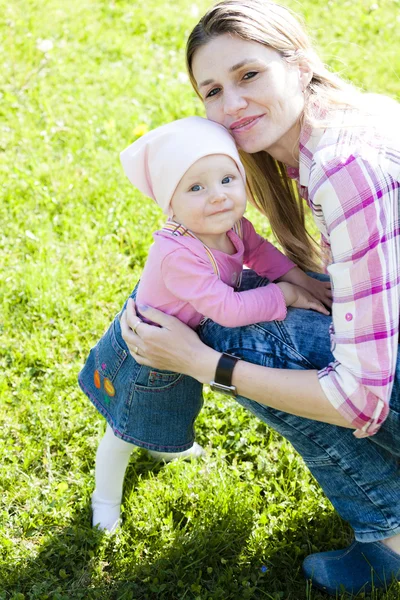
[121,117,246,216]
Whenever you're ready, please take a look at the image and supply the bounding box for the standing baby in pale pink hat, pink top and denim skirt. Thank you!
[79,117,329,531]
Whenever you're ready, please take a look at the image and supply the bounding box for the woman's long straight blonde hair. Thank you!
[186,0,358,271]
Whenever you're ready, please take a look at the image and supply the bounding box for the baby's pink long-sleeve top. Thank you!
[137,218,296,329]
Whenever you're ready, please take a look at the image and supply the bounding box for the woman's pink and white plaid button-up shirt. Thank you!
[288,104,400,437]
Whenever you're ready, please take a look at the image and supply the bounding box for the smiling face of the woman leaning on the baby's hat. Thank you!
[192,34,311,166]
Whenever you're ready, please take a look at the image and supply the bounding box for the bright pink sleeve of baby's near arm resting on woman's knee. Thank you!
[161,248,287,327]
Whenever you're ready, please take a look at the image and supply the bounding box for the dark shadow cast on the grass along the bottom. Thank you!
[0,457,400,600]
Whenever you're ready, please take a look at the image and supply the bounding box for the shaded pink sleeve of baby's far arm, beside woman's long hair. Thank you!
[242,217,296,281]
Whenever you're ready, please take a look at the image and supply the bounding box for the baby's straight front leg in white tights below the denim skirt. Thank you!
[92,425,135,532]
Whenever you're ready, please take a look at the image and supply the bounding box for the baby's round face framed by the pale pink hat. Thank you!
[171,154,246,235]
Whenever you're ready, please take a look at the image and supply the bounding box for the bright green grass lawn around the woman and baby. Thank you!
[0,0,400,600]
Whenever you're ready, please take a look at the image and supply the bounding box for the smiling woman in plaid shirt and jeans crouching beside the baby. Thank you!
[121,0,400,594]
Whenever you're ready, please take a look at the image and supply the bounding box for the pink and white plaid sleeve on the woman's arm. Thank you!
[309,155,399,437]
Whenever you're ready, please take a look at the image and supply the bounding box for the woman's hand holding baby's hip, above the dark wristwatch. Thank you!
[120,298,220,383]
